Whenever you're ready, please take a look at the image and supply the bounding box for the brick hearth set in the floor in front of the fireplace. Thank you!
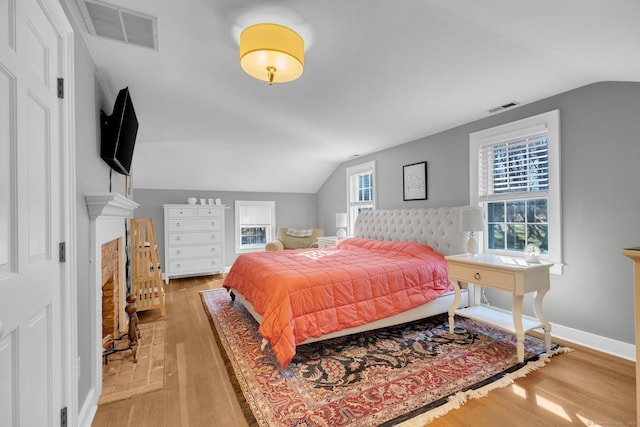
[98,319,166,405]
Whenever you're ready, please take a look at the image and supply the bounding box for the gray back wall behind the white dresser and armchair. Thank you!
[133,189,316,267]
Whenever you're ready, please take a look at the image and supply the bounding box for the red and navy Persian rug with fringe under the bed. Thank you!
[200,289,564,427]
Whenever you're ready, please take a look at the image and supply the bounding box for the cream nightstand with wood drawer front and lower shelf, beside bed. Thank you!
[445,254,552,362]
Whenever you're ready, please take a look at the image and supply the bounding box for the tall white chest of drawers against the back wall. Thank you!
[163,205,224,283]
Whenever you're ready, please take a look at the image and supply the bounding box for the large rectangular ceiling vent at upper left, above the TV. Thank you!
[78,0,158,50]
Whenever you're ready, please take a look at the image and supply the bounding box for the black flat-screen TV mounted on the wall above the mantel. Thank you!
[100,87,138,175]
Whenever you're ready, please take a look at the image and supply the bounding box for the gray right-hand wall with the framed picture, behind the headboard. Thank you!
[317,82,640,343]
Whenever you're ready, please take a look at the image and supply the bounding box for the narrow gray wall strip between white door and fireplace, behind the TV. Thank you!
[69,20,125,408]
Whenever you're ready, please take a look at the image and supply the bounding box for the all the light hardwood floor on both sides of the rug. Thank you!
[93,276,636,427]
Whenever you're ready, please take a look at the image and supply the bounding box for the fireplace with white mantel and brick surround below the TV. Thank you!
[85,193,138,404]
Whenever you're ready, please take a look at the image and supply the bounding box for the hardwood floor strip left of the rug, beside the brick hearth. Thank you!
[92,276,247,427]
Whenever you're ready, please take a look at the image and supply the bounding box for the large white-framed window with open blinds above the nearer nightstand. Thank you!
[469,110,562,273]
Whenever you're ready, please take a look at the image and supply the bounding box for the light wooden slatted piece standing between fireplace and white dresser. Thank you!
[131,218,165,316]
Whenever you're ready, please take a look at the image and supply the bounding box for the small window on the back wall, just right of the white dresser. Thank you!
[235,200,276,252]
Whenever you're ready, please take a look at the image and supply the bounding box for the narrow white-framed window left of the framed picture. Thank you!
[347,162,376,236]
